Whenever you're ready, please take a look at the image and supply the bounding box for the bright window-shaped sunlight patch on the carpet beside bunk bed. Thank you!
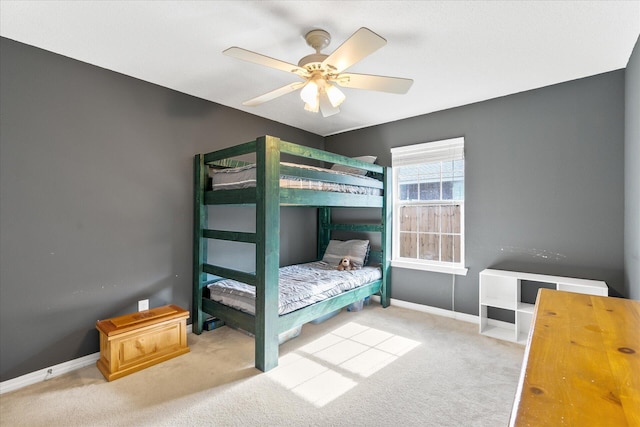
[267,322,420,407]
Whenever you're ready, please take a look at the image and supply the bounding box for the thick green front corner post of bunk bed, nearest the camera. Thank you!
[255,136,280,372]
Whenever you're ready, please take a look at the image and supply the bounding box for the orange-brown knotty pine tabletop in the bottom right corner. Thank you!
[509,289,640,427]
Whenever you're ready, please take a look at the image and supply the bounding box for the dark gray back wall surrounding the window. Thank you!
[325,70,637,314]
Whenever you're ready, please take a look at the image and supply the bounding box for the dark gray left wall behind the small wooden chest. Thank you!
[0,38,323,381]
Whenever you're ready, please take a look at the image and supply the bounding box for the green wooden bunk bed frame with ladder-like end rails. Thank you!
[192,136,391,372]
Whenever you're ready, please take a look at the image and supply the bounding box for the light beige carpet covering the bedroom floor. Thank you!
[0,304,524,427]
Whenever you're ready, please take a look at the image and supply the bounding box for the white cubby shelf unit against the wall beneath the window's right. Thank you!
[479,269,609,344]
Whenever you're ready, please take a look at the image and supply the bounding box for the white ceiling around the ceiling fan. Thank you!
[0,0,640,136]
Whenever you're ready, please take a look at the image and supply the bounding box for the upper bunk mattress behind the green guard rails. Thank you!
[209,162,382,196]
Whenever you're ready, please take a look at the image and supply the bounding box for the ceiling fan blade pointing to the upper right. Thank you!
[322,27,387,73]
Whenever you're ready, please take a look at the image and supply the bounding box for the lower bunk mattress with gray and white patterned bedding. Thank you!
[207,261,382,314]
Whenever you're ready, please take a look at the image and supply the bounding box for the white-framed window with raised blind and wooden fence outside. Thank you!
[391,138,467,274]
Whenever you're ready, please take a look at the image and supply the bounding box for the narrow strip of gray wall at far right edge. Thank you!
[624,37,640,300]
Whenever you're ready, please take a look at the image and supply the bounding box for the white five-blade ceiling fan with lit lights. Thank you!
[222,27,413,117]
